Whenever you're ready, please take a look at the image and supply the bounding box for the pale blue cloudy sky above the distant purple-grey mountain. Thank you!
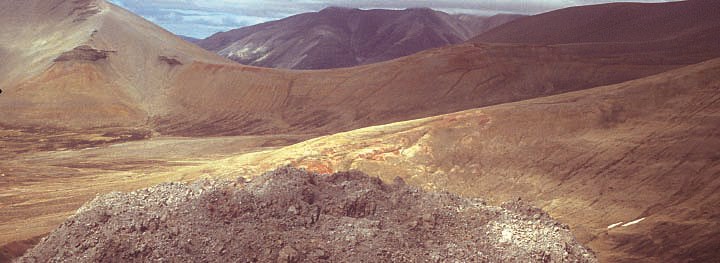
[105,0,668,38]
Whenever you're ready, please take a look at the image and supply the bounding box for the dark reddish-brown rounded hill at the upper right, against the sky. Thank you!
[473,0,720,44]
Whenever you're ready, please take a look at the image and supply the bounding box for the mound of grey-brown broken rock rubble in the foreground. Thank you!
[19,167,597,262]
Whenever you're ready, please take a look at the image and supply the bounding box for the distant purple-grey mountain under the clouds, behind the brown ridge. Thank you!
[197,7,520,69]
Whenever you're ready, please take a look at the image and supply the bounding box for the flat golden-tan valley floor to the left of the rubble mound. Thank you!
[0,132,313,261]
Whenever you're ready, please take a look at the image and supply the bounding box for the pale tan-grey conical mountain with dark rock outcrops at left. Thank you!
[0,0,226,127]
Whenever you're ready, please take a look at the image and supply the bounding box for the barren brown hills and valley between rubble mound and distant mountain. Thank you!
[0,0,720,262]
